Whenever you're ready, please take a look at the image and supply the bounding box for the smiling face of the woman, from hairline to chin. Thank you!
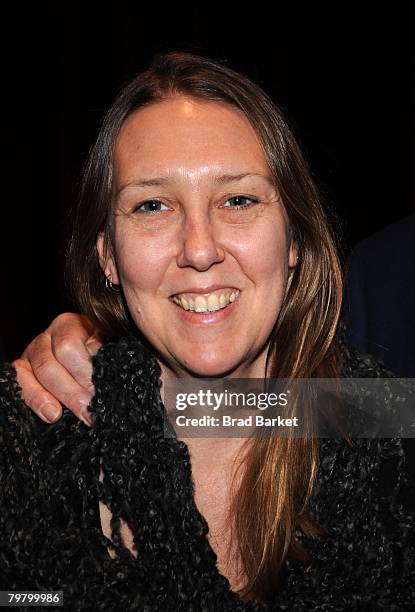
[97,96,297,378]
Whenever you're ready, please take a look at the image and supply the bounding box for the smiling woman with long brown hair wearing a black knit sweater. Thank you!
[0,53,414,610]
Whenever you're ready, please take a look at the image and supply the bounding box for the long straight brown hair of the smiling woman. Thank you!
[67,52,342,601]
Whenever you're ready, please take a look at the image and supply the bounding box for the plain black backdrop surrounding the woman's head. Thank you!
[0,1,415,359]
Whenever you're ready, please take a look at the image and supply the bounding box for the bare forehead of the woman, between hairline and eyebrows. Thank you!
[114,96,269,182]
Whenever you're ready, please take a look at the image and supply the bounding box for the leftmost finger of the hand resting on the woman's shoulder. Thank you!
[12,359,62,423]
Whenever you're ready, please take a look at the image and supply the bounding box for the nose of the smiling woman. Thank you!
[177,217,225,272]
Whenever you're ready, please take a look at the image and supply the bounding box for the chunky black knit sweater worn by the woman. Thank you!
[0,337,415,612]
